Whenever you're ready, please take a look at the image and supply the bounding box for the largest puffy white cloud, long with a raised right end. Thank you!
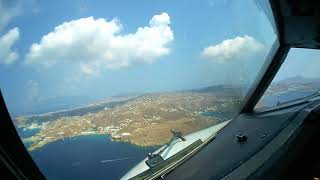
[26,13,174,75]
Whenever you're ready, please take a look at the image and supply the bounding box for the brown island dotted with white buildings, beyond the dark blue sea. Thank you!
[14,86,240,151]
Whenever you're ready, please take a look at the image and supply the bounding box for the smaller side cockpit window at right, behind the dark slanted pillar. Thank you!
[256,48,320,108]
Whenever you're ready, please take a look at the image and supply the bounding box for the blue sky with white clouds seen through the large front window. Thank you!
[0,0,318,112]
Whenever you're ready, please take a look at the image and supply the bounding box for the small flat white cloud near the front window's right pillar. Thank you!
[202,35,265,63]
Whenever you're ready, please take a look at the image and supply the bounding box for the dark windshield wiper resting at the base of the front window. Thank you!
[146,129,187,168]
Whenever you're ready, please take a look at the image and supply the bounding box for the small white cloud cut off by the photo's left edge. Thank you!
[0,27,20,64]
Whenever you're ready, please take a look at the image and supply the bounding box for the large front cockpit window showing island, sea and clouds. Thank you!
[0,0,279,179]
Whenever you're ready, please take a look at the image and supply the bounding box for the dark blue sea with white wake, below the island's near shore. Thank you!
[31,135,157,180]
